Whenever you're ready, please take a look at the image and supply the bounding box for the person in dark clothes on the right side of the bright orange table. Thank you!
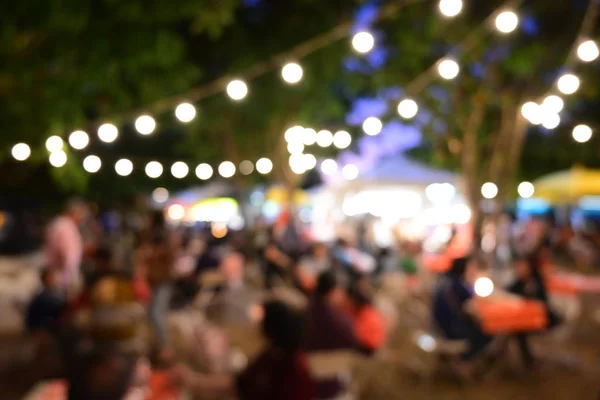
[508,255,559,367]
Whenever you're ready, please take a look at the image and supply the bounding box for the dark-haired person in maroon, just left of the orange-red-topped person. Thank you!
[307,271,361,399]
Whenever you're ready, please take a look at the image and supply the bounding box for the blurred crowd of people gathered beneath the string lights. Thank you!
[19,200,572,400]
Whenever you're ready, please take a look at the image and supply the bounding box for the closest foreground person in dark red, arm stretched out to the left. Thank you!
[172,300,315,400]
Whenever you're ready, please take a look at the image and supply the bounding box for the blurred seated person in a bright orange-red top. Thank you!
[348,285,387,355]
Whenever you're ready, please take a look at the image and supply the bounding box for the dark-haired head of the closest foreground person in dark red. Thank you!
[262,300,306,351]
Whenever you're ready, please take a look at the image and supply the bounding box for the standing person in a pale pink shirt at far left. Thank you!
[45,199,88,292]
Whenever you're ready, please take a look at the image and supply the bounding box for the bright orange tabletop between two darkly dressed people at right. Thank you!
[475,298,548,335]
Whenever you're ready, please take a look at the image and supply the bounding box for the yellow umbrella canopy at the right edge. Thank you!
[533,166,600,203]
